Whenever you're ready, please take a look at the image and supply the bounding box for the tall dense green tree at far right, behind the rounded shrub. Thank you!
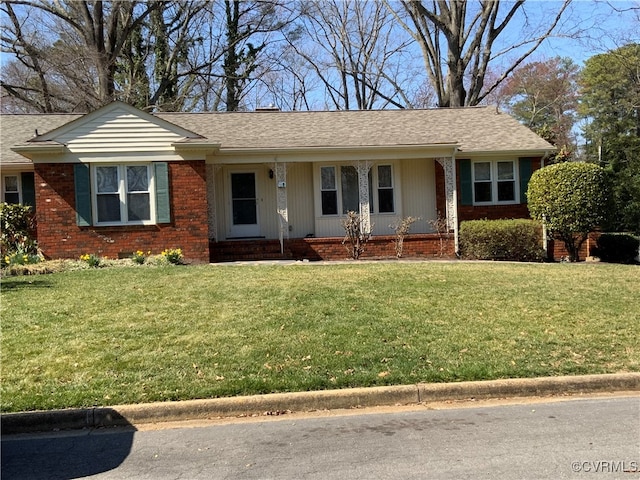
[579,43,640,233]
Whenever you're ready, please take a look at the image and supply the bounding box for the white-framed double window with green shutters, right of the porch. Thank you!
[472,160,518,205]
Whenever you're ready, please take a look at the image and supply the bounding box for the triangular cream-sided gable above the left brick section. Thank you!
[29,102,202,153]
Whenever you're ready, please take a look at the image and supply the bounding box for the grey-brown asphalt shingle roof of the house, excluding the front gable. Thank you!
[0,107,553,164]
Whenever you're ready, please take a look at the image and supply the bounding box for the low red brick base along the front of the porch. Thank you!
[209,233,455,263]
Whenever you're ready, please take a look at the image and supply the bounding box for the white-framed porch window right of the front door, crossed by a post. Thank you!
[320,165,395,215]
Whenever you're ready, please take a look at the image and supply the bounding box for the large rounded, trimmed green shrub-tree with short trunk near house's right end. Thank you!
[527,162,610,262]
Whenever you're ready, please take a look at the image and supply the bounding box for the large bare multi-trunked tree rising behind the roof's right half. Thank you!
[385,0,570,107]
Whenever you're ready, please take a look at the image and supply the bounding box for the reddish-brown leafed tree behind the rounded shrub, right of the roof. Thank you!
[501,57,579,161]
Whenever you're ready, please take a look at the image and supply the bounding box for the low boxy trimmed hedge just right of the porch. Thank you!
[460,219,545,262]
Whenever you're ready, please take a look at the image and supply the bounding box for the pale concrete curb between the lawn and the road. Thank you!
[0,372,640,435]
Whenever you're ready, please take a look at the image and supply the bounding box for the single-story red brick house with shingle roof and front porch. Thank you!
[0,102,554,262]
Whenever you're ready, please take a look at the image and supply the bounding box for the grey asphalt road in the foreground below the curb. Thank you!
[2,396,640,480]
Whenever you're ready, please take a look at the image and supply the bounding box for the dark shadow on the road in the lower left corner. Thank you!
[1,409,136,480]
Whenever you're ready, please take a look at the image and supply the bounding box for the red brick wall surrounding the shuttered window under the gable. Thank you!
[35,160,209,262]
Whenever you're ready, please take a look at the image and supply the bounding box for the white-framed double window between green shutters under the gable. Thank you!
[91,164,155,225]
